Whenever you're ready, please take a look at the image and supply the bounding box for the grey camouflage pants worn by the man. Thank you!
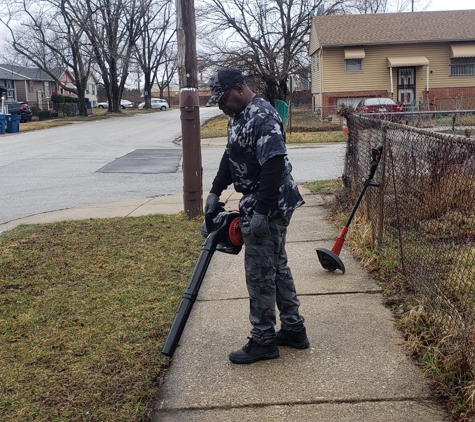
[242,213,304,344]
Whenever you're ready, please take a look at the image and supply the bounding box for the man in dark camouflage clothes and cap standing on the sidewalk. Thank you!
[205,69,309,364]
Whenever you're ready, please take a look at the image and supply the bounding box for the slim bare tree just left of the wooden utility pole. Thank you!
[135,0,176,108]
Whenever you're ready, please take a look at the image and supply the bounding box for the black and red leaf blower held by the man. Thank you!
[162,202,244,357]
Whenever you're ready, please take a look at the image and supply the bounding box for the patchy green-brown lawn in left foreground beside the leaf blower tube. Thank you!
[0,214,203,422]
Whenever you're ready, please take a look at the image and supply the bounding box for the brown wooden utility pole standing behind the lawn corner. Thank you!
[176,0,203,217]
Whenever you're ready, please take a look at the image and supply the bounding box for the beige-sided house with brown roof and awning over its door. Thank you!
[309,10,475,117]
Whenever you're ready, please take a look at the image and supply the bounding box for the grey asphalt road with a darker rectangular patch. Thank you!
[0,107,345,223]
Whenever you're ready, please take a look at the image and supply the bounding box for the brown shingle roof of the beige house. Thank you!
[313,10,475,47]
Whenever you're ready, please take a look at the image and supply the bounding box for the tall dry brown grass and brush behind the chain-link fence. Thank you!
[326,167,475,420]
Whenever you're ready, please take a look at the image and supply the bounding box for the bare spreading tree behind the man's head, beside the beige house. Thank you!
[198,0,345,100]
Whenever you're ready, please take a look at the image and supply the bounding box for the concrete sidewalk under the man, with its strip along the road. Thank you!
[0,189,450,422]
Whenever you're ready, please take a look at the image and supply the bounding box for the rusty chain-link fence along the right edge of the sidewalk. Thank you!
[340,112,475,409]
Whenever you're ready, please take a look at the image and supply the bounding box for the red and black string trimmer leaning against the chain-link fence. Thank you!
[317,145,383,274]
